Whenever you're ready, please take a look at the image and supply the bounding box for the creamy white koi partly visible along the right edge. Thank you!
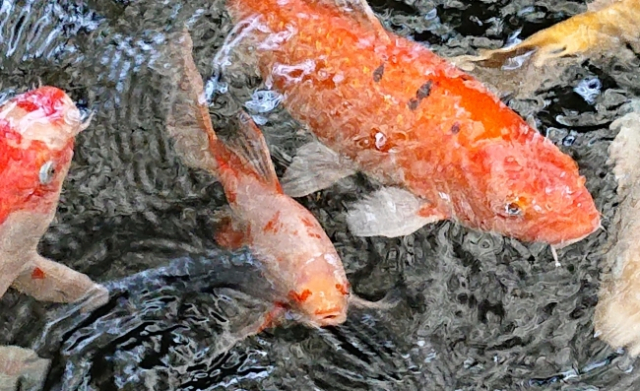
[594,109,640,357]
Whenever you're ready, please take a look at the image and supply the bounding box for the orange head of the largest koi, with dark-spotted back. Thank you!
[470,138,600,248]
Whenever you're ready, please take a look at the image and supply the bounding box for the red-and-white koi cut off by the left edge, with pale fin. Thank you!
[0,86,108,305]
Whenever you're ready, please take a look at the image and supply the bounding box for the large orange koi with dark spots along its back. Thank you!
[227,0,600,248]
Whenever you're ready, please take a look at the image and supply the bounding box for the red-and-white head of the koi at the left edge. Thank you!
[0,86,88,224]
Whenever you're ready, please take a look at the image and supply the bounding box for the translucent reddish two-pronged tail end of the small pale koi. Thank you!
[167,28,282,192]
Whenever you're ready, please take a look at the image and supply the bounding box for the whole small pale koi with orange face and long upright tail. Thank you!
[168,31,350,326]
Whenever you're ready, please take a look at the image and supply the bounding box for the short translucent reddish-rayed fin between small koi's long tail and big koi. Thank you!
[221,111,282,193]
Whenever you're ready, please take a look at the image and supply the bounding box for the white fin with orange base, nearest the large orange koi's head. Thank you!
[347,187,448,238]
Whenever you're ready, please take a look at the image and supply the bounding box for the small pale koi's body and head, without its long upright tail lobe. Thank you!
[212,115,349,326]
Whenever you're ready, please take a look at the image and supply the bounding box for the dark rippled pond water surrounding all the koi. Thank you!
[0,0,640,391]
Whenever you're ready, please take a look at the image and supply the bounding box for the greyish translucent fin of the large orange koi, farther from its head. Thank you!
[282,141,356,197]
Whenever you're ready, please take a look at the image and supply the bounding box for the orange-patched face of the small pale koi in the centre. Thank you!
[289,258,350,327]
